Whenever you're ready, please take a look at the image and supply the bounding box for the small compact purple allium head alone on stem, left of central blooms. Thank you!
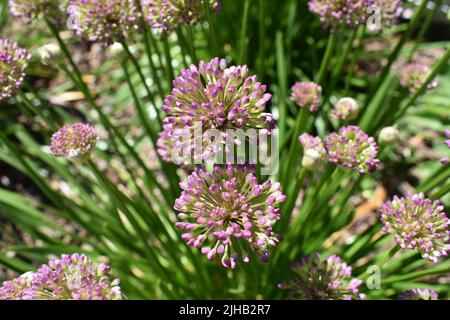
[50,123,98,162]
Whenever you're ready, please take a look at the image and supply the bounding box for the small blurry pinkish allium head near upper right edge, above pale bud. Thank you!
[398,63,438,93]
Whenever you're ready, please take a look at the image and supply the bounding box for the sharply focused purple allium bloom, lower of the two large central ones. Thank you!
[174,165,285,268]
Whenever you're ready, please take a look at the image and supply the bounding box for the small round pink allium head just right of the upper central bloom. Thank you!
[291,82,322,112]
